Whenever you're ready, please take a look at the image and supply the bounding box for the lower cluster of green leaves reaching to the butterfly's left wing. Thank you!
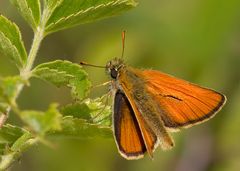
[0,98,112,170]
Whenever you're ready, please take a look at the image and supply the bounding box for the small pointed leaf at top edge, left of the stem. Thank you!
[11,0,41,30]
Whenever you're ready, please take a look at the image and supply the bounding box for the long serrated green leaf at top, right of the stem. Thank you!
[46,0,136,33]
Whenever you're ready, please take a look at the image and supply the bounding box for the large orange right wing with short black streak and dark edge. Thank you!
[142,70,226,130]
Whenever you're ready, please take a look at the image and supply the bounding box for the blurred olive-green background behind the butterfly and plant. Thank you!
[0,0,240,171]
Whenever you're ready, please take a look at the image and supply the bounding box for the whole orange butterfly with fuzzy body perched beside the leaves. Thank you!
[81,32,226,159]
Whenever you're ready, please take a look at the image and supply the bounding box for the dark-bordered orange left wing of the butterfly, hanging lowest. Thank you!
[113,91,157,159]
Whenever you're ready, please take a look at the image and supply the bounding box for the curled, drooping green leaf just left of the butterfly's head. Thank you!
[33,60,91,99]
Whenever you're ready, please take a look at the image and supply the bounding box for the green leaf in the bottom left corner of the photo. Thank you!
[0,124,37,170]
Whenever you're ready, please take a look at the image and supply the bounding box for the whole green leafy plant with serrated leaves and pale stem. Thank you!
[0,0,136,170]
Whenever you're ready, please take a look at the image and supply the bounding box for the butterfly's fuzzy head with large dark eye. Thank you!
[106,58,124,79]
